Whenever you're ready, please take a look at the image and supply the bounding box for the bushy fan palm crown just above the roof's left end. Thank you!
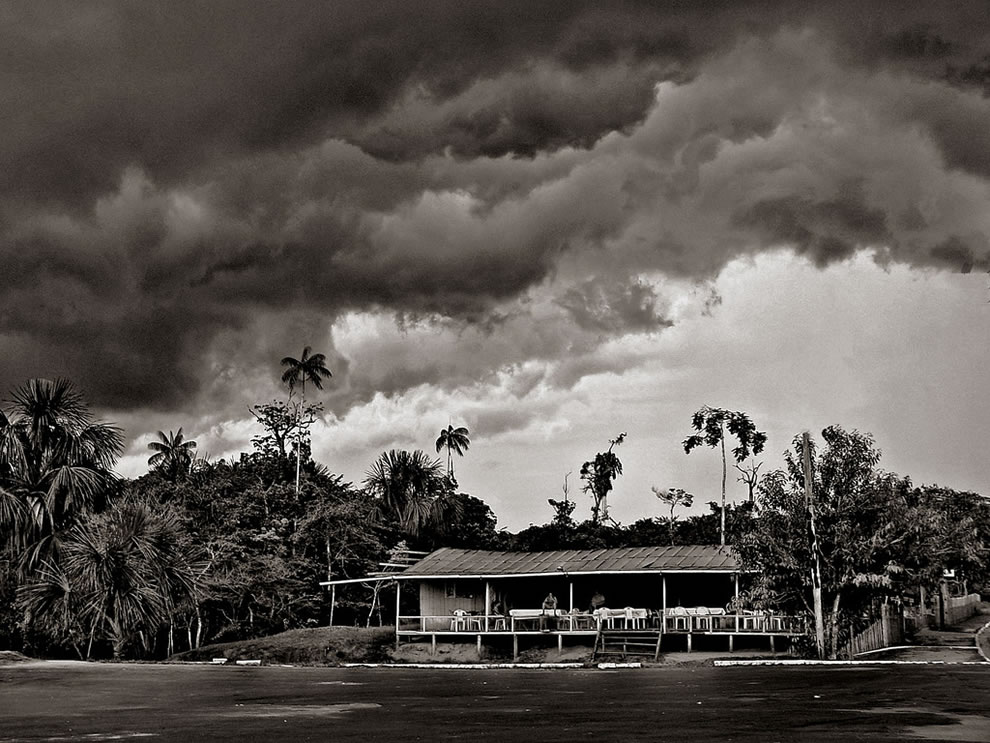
[364,449,460,538]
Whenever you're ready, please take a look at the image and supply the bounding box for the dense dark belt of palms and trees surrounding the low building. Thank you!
[0,378,990,657]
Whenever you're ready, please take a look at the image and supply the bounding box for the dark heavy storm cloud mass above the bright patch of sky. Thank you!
[0,0,990,418]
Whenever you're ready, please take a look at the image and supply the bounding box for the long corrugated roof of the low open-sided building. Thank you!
[398,545,740,578]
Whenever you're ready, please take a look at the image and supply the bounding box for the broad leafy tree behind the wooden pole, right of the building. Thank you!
[736,426,986,657]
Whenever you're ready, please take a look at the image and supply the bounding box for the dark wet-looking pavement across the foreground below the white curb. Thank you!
[0,664,990,743]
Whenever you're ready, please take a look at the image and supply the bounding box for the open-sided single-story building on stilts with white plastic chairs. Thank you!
[322,545,803,655]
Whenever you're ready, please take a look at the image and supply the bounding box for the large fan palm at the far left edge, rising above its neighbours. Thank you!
[0,379,124,572]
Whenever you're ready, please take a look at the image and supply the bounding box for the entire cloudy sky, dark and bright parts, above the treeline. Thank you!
[0,0,990,530]
